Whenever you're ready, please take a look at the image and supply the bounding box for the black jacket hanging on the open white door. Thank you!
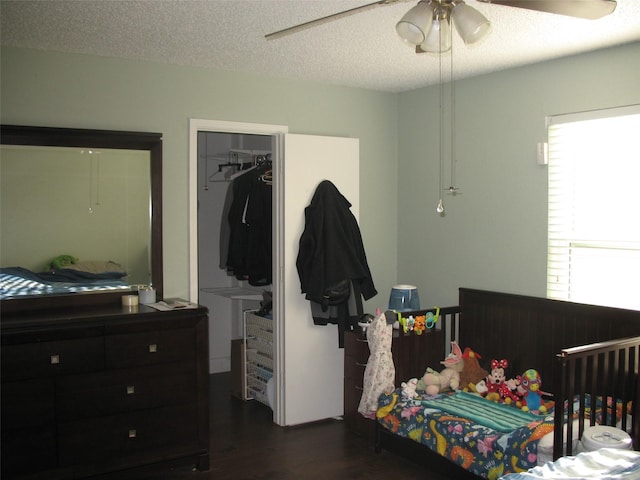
[296,180,378,347]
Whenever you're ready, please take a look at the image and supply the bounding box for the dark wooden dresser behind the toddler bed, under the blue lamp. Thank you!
[344,318,454,438]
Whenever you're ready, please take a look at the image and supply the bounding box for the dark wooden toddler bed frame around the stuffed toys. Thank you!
[375,288,640,479]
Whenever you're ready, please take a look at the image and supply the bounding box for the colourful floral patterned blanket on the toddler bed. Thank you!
[376,389,553,480]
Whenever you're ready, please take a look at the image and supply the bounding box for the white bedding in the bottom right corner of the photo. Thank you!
[500,448,640,480]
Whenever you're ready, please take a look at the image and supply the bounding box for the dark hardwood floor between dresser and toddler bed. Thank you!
[100,373,448,480]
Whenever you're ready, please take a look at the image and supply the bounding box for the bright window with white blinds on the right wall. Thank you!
[547,105,640,310]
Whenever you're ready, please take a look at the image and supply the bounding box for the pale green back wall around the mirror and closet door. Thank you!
[0,48,398,309]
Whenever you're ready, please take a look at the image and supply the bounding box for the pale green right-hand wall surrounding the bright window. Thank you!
[398,39,640,306]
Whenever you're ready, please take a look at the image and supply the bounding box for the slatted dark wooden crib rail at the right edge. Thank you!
[553,336,640,460]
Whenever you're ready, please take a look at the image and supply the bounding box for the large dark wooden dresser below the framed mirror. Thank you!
[1,305,209,479]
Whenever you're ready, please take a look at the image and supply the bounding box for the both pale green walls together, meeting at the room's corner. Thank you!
[0,43,640,310]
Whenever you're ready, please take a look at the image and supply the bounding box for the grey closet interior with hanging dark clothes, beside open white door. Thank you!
[197,131,273,373]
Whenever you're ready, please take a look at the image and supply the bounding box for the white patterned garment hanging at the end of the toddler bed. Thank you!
[358,313,396,418]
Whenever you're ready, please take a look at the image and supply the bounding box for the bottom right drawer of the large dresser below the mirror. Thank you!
[58,404,198,466]
